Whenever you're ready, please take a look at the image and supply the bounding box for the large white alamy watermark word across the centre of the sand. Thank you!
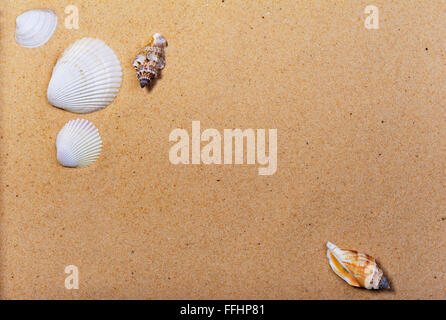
[169,121,277,175]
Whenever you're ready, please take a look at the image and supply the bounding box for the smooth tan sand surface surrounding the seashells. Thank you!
[0,0,446,299]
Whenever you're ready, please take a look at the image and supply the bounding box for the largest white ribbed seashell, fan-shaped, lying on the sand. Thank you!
[47,38,122,113]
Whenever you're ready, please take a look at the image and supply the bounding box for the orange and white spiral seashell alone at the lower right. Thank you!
[327,241,390,289]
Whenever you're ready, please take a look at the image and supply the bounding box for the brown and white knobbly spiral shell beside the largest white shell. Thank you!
[133,33,167,88]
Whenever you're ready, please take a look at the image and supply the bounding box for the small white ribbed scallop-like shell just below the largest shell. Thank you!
[56,119,102,168]
